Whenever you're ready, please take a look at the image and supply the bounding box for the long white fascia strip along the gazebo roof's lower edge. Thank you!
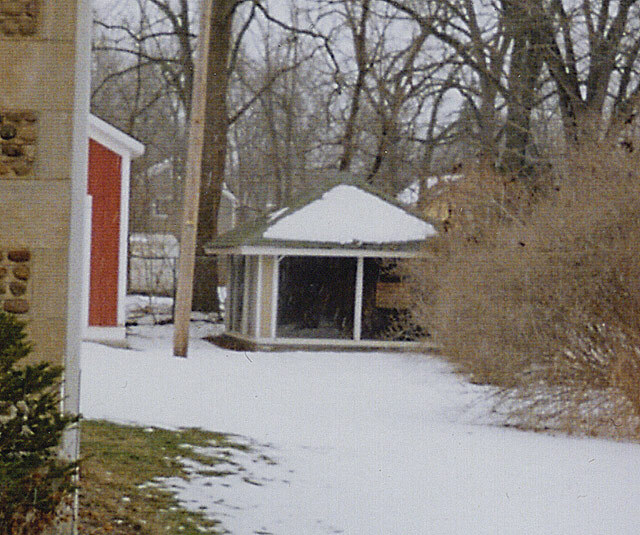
[206,245,431,258]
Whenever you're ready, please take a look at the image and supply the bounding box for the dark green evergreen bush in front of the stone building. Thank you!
[0,312,75,535]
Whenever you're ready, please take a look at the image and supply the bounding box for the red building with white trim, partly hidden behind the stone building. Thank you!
[85,116,144,340]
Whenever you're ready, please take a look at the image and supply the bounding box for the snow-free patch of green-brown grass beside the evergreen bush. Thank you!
[79,420,248,535]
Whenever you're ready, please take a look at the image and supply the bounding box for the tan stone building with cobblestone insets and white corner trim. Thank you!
[0,0,91,506]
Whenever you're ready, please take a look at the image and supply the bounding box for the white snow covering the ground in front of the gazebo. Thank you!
[81,324,640,535]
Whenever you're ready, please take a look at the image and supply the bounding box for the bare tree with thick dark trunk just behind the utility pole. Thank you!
[94,0,340,310]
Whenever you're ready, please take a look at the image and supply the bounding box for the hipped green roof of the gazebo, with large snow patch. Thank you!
[207,183,436,254]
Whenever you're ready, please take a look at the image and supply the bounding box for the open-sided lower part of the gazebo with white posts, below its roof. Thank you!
[226,255,421,345]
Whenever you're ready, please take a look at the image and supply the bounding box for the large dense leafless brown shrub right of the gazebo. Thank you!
[413,144,640,440]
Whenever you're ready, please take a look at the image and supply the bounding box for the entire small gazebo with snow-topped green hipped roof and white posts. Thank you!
[206,181,436,347]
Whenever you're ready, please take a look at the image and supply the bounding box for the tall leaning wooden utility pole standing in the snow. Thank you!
[173,0,214,357]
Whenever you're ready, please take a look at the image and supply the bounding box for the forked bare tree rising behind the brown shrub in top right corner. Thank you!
[539,0,640,142]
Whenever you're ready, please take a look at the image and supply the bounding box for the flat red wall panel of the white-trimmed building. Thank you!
[88,139,122,327]
